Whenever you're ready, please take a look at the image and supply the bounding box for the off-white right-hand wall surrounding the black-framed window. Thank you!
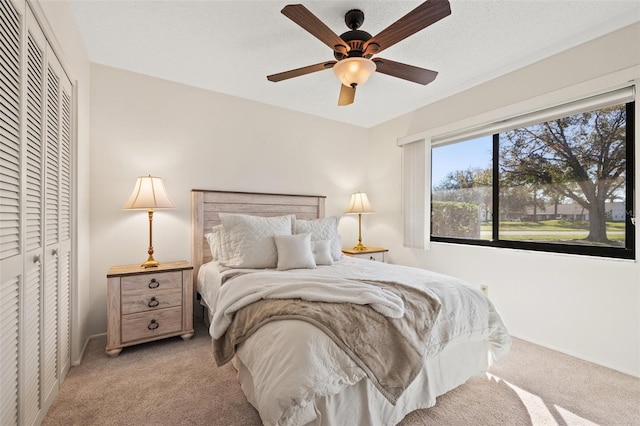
[366,24,640,376]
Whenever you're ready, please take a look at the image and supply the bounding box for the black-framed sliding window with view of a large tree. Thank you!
[431,102,635,258]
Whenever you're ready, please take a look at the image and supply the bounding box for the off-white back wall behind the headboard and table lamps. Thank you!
[89,65,367,333]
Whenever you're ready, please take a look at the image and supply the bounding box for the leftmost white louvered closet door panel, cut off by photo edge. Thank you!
[0,1,24,425]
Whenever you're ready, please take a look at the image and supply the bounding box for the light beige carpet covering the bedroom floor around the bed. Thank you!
[43,322,640,426]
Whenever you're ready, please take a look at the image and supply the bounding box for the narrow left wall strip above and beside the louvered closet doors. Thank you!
[33,1,92,364]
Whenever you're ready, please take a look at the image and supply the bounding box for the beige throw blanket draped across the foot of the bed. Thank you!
[213,281,440,405]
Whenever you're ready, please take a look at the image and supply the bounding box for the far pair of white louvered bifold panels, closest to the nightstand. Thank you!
[42,42,72,406]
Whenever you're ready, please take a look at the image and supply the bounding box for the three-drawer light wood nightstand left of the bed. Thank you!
[105,261,193,356]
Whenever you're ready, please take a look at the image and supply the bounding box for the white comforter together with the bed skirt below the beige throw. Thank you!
[201,258,511,425]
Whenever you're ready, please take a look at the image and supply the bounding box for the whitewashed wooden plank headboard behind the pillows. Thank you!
[191,189,326,294]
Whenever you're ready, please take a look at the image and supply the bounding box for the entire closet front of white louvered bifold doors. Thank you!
[0,0,74,426]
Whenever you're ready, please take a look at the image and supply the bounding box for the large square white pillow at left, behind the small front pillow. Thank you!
[219,213,292,268]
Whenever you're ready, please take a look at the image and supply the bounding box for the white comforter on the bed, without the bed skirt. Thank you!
[201,258,511,425]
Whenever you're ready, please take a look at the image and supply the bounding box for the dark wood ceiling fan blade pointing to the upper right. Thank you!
[364,0,451,54]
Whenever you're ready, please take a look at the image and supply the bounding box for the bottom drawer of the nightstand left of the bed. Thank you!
[122,307,182,343]
